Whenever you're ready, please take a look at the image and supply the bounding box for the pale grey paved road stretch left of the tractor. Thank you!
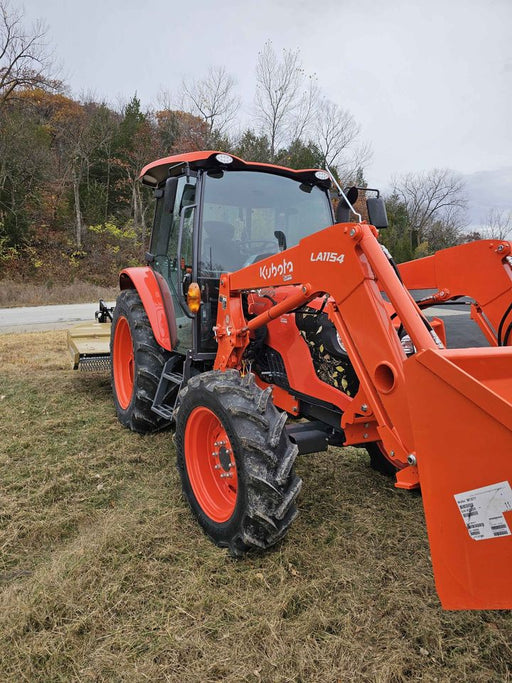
[0,302,114,334]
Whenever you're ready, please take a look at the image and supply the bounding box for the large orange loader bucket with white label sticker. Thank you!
[404,347,512,609]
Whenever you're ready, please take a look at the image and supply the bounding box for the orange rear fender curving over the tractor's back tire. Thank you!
[119,266,178,351]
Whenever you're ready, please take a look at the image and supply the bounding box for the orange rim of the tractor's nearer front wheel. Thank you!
[185,406,238,523]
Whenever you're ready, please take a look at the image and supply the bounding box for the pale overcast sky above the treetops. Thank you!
[20,0,512,223]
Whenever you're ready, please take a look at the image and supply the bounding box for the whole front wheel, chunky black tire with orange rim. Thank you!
[175,370,302,556]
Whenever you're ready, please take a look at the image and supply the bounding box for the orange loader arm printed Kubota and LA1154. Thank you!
[215,224,435,467]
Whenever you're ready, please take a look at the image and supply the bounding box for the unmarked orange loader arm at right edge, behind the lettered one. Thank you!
[399,240,512,346]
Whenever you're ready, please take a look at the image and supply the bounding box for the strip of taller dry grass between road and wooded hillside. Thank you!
[0,279,119,308]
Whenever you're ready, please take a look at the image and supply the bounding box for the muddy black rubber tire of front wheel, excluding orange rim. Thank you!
[176,370,302,557]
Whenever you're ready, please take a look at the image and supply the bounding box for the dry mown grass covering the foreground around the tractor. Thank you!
[0,332,512,683]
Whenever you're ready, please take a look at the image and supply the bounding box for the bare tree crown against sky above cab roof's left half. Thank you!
[181,66,240,138]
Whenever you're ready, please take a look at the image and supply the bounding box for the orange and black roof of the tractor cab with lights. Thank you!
[139,150,331,189]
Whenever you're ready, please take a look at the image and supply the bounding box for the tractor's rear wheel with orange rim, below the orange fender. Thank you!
[110,289,172,434]
